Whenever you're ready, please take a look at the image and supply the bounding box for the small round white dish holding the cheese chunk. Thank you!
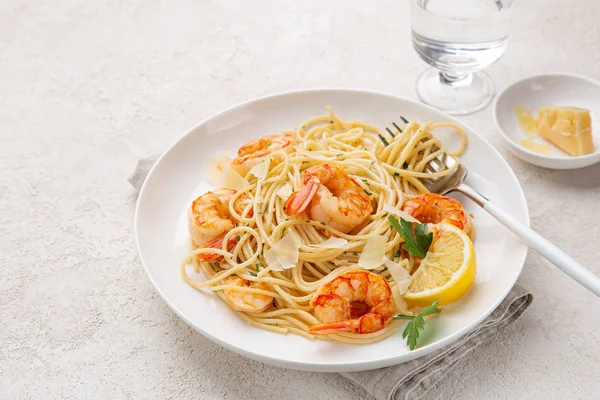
[494,74,600,169]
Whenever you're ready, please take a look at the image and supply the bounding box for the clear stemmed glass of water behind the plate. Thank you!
[410,0,512,115]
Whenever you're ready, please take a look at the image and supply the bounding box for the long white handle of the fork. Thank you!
[456,184,600,297]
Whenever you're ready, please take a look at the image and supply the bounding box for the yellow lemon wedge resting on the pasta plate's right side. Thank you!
[404,224,477,306]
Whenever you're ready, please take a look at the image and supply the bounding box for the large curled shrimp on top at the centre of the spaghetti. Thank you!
[285,164,373,233]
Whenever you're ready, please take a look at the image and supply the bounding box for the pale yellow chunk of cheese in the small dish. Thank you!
[537,107,594,156]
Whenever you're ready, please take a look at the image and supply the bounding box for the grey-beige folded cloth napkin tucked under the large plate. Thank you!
[129,155,533,400]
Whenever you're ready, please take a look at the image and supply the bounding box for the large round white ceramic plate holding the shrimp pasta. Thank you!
[135,89,529,372]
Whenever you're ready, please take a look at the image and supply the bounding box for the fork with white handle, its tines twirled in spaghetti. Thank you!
[380,117,600,297]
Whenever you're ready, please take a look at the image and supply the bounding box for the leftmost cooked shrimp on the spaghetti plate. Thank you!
[188,189,252,261]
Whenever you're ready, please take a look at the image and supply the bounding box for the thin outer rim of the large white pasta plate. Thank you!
[134,87,530,372]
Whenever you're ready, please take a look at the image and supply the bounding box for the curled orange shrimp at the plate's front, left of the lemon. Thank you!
[309,270,396,334]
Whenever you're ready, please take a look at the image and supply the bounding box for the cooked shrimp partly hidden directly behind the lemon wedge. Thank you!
[402,193,472,235]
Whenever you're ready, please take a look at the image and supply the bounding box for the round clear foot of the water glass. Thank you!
[417,68,495,115]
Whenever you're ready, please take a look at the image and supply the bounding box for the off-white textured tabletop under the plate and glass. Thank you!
[0,0,600,399]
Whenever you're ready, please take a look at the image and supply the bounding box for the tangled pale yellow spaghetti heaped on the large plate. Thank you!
[181,109,467,343]
